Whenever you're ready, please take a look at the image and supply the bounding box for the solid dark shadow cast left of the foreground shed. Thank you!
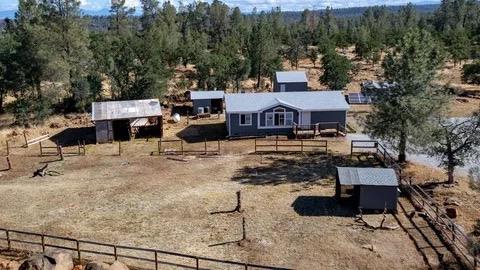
[292,196,356,217]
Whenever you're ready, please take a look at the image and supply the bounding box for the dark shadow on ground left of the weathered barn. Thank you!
[50,127,96,146]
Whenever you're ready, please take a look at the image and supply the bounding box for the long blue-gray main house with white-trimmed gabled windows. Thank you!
[225,91,349,137]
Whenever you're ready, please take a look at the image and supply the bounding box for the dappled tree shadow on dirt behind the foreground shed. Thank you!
[232,154,381,185]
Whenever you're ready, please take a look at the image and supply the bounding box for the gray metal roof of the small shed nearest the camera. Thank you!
[337,167,398,187]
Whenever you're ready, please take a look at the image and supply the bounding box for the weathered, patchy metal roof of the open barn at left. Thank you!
[92,99,162,121]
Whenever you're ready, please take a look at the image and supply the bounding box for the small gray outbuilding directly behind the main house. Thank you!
[273,71,308,92]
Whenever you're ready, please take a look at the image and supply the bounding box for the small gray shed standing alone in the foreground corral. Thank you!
[335,167,398,211]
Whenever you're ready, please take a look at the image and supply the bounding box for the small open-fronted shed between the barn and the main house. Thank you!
[190,91,225,114]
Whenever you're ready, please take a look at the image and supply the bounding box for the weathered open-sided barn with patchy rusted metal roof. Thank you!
[92,99,162,143]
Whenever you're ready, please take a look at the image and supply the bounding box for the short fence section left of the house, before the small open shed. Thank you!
[151,139,220,155]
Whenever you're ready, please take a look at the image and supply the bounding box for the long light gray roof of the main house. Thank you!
[225,91,350,113]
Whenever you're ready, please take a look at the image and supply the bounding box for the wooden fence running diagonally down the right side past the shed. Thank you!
[350,140,480,269]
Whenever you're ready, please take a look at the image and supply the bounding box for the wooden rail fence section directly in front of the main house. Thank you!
[255,137,328,154]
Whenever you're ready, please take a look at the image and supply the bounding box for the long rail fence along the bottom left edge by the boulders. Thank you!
[0,228,288,270]
